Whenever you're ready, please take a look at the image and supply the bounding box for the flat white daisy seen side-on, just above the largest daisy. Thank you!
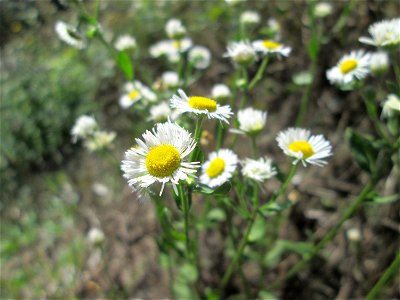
[171,90,233,123]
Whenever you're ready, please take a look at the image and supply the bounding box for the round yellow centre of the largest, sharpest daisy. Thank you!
[146,144,181,177]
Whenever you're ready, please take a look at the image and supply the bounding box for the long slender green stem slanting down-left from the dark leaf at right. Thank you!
[272,179,377,287]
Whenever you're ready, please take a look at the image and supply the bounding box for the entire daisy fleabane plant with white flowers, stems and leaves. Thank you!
[57,3,400,299]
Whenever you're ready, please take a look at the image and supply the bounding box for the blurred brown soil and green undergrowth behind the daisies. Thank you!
[0,0,400,299]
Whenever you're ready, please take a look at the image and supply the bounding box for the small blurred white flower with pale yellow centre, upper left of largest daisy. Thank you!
[119,80,157,109]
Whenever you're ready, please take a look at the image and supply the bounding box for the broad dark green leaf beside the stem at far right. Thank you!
[345,128,379,174]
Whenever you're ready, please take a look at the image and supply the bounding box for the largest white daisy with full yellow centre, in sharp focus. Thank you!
[121,121,199,196]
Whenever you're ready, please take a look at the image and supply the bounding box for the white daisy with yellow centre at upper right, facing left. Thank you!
[326,50,371,85]
